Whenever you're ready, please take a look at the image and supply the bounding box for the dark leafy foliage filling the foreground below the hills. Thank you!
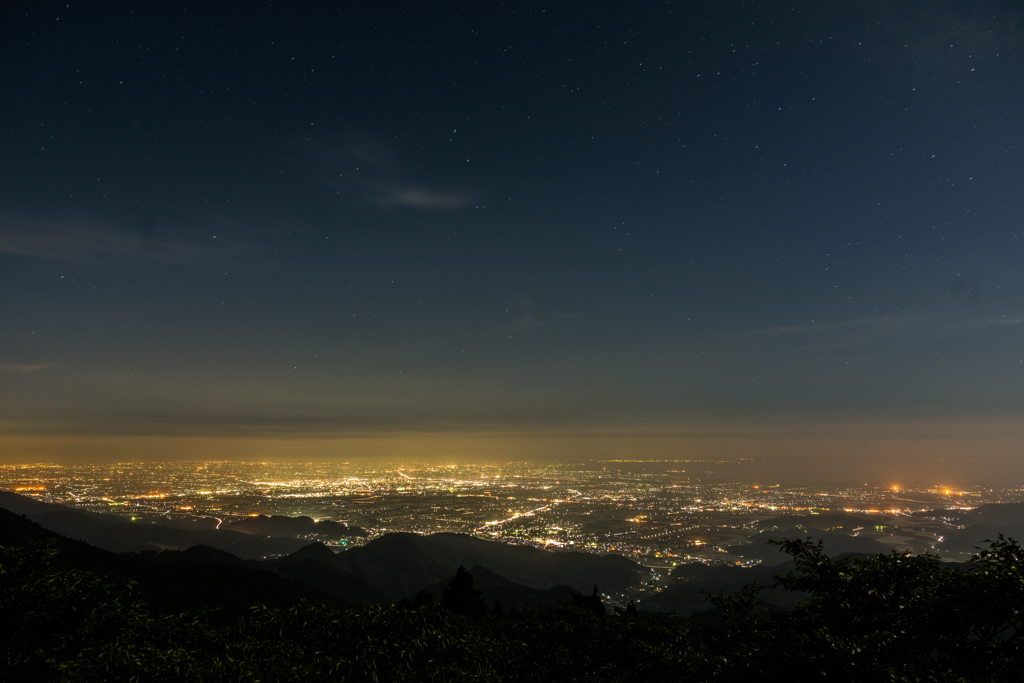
[0,537,1024,683]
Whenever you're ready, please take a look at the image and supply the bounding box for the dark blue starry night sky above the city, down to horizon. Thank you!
[0,0,1024,478]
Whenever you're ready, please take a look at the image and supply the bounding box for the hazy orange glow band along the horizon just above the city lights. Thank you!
[0,420,1024,483]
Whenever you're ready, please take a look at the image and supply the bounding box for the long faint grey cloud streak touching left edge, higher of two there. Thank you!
[0,215,251,266]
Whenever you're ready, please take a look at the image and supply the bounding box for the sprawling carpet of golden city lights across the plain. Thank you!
[0,462,999,568]
